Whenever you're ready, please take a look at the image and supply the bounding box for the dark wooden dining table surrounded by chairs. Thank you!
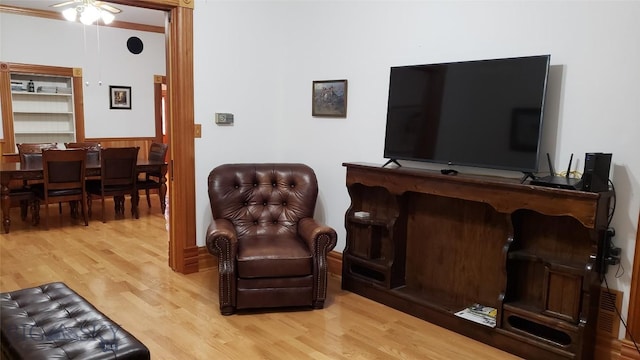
[0,159,168,234]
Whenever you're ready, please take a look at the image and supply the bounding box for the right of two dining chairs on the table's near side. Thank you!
[87,146,140,222]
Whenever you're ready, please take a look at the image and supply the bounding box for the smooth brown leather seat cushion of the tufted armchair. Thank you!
[237,234,313,278]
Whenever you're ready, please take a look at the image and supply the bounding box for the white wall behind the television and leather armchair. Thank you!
[194,0,640,334]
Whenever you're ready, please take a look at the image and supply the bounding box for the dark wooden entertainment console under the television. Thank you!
[342,163,612,359]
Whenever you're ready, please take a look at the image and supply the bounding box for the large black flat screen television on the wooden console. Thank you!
[384,55,550,174]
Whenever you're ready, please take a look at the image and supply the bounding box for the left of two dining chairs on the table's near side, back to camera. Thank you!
[34,149,89,229]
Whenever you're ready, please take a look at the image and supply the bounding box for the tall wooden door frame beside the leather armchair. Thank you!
[110,0,198,274]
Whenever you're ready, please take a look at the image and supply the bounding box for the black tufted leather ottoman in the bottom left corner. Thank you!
[0,282,150,360]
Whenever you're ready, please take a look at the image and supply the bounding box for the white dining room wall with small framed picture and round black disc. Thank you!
[0,12,166,138]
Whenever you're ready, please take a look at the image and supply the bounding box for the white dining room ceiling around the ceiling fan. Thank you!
[0,0,165,26]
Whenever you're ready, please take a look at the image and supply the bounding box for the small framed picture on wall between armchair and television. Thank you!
[311,80,347,117]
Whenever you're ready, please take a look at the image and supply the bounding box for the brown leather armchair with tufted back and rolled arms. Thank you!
[206,164,337,315]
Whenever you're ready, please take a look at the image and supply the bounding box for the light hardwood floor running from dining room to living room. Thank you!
[0,201,517,360]
